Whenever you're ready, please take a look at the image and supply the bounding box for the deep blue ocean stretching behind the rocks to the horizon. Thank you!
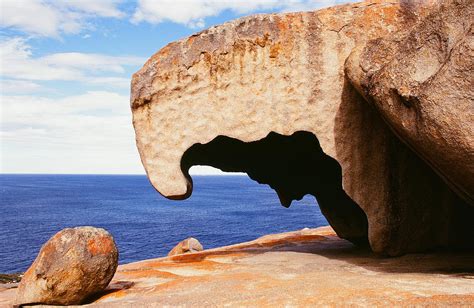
[0,174,328,273]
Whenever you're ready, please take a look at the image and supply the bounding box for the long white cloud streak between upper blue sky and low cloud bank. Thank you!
[0,37,146,87]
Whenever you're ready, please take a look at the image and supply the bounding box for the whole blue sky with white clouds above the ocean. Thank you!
[0,0,356,174]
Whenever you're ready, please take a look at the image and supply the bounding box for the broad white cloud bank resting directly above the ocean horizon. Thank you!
[0,91,143,173]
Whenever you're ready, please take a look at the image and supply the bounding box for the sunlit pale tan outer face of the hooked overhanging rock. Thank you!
[131,1,408,197]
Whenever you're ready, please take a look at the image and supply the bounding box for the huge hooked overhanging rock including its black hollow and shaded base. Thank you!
[131,1,473,255]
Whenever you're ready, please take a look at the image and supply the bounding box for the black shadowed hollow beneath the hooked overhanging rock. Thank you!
[181,131,368,244]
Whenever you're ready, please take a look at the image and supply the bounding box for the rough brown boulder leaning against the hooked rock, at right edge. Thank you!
[347,0,474,206]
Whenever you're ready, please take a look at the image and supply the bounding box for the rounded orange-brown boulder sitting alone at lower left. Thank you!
[15,227,118,305]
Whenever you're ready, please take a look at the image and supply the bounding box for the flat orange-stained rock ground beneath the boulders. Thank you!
[0,227,474,307]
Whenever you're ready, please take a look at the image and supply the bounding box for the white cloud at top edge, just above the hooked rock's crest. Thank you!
[131,0,355,28]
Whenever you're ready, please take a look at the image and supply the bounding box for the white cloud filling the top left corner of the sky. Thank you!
[0,0,124,37]
